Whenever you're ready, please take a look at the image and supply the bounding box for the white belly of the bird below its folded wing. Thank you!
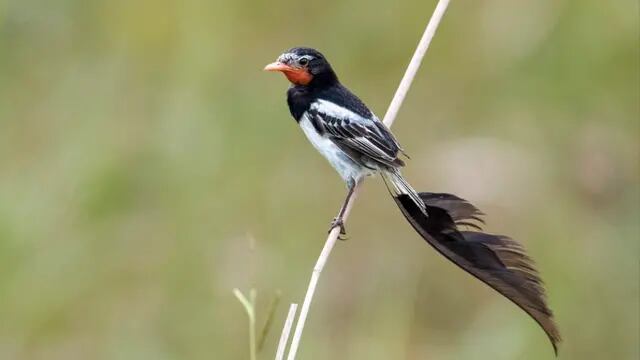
[299,114,373,182]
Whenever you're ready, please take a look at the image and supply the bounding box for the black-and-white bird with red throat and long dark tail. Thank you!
[264,47,561,355]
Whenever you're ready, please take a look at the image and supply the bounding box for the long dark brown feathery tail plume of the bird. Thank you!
[394,193,560,355]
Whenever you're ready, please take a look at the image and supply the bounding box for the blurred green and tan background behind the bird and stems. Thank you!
[0,0,640,360]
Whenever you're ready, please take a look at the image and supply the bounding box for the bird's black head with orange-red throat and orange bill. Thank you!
[264,47,338,86]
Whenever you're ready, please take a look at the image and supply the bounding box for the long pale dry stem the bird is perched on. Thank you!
[287,0,449,360]
